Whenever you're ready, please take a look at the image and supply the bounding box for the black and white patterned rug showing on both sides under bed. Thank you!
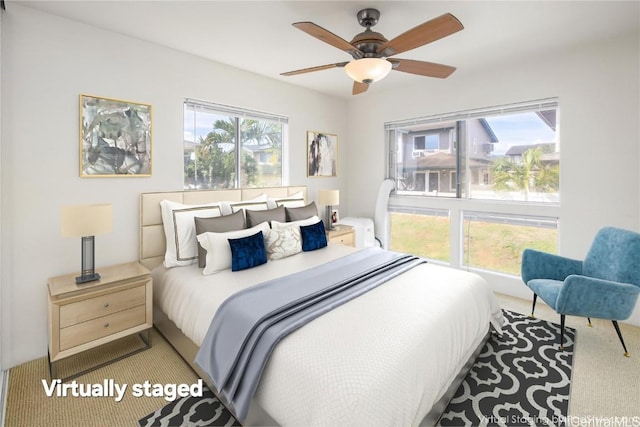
[138,310,575,427]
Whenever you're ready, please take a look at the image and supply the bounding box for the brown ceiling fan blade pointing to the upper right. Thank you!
[378,13,464,57]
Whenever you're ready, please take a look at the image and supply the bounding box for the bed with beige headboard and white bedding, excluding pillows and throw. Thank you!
[140,187,502,425]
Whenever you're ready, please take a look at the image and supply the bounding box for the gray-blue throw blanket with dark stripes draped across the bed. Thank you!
[195,248,426,422]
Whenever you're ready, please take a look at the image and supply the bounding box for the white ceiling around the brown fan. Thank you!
[13,0,640,97]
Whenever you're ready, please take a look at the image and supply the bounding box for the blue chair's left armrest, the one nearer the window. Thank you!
[520,249,582,283]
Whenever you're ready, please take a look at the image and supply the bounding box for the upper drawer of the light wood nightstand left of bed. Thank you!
[60,280,147,328]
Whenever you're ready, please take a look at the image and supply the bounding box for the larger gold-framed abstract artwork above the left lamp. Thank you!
[80,94,151,177]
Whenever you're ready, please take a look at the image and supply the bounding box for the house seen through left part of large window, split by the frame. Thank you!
[397,119,498,195]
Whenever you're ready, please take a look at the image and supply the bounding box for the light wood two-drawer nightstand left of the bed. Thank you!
[48,262,153,381]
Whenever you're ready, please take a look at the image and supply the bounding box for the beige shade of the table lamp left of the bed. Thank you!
[60,204,113,237]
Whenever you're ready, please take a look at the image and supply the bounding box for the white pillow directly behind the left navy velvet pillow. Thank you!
[197,222,269,275]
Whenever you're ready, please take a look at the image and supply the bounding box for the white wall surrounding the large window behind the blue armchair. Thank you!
[347,33,640,325]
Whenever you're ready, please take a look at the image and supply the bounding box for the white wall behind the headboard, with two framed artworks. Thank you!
[0,2,347,367]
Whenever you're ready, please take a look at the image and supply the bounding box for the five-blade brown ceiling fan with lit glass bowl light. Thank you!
[281,8,464,95]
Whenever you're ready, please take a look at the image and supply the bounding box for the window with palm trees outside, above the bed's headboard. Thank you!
[184,100,287,189]
